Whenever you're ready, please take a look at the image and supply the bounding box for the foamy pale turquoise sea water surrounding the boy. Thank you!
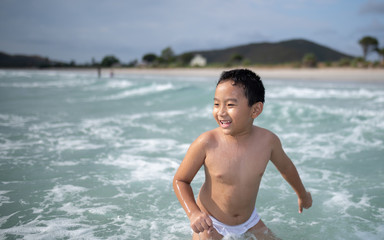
[0,70,384,239]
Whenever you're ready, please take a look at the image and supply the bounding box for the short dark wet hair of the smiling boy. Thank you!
[216,69,265,107]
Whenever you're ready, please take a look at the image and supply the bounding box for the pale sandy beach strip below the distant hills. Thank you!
[2,67,384,83]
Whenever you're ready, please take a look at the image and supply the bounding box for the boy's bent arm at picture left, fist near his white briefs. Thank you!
[173,136,213,233]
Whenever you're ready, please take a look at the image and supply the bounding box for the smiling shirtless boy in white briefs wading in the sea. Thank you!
[173,69,312,239]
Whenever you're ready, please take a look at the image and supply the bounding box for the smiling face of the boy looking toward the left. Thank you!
[213,80,255,136]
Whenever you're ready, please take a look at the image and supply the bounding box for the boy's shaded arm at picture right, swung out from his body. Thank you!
[271,136,312,213]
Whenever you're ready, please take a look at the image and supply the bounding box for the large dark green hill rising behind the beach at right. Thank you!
[184,39,353,64]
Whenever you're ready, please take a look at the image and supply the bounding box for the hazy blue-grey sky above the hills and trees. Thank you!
[0,0,384,63]
